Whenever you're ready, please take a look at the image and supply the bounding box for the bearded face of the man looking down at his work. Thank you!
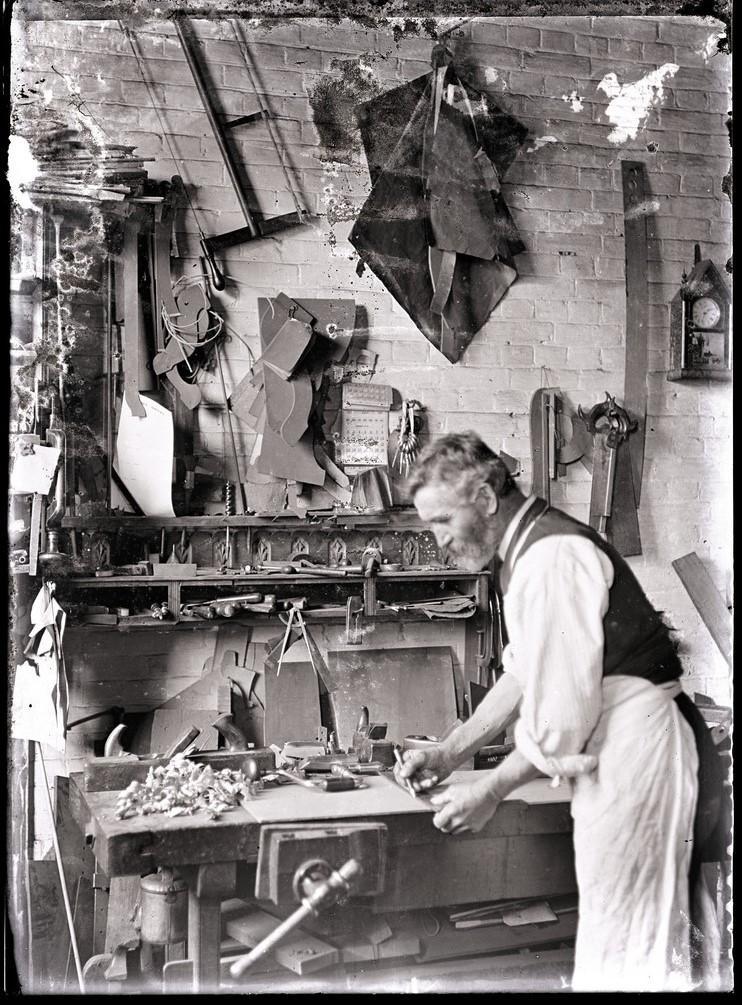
[414,481,497,572]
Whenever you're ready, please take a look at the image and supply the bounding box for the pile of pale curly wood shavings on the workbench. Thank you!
[116,756,251,820]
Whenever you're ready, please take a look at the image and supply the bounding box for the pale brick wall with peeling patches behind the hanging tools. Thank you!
[14,17,732,844]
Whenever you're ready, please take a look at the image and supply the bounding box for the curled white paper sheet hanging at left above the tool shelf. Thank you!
[114,396,175,517]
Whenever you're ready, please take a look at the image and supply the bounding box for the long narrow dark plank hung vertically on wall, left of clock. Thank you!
[621,161,652,510]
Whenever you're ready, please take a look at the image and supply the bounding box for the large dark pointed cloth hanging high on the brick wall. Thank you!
[350,65,528,363]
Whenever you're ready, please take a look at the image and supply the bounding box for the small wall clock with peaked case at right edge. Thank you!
[668,244,732,380]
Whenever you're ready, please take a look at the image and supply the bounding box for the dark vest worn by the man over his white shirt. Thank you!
[500,499,683,684]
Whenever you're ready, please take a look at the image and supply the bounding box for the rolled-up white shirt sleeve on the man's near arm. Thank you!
[503,535,613,778]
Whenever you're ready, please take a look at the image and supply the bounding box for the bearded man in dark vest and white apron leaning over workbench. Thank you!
[396,432,721,991]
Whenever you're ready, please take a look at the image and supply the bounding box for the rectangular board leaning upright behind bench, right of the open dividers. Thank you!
[327,646,456,749]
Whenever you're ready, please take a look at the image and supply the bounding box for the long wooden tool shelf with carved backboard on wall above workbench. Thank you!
[49,512,490,709]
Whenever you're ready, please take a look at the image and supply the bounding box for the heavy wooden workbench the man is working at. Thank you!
[70,772,576,991]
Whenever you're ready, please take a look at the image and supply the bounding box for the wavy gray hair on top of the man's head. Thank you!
[406,430,515,498]
